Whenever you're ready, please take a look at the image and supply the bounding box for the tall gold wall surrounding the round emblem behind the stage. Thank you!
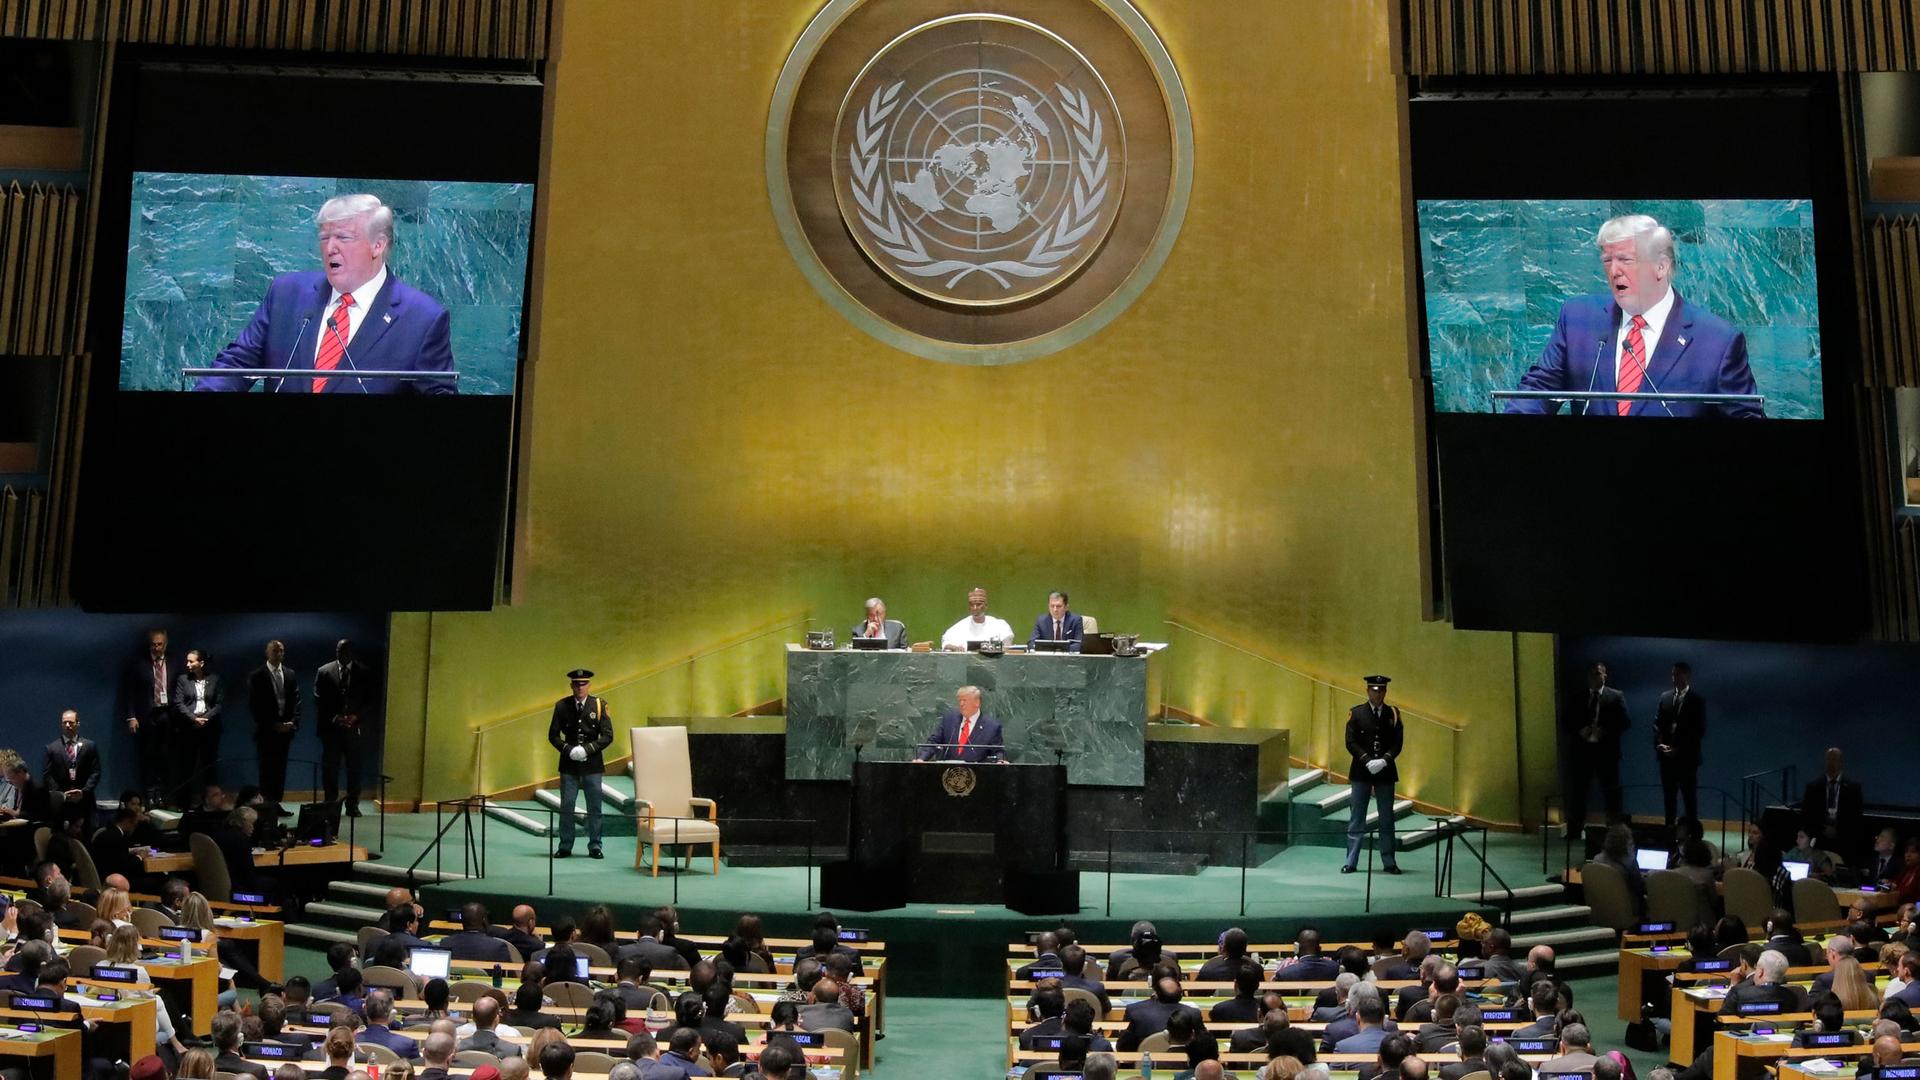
[388,0,1551,821]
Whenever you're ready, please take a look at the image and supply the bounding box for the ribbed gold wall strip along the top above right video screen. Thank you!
[1400,0,1920,75]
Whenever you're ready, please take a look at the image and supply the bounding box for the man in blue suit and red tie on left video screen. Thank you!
[194,194,455,394]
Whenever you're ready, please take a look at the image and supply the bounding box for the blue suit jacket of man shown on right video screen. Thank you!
[1505,292,1764,419]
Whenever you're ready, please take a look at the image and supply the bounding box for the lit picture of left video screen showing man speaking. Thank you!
[119,173,534,396]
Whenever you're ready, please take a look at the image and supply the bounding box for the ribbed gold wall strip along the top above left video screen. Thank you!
[0,0,551,60]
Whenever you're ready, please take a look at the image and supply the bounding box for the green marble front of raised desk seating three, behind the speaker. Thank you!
[787,644,1158,788]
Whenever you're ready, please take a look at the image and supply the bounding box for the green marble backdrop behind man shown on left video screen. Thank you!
[119,173,534,394]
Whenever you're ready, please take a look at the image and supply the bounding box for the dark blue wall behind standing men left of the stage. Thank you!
[0,611,386,799]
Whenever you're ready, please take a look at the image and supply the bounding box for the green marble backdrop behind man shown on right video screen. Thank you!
[1419,200,1820,419]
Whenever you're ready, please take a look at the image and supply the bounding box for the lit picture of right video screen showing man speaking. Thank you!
[1417,198,1824,419]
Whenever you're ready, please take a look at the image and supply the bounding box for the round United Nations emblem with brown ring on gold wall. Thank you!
[768,0,1192,363]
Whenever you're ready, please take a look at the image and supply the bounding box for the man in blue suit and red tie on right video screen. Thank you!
[1505,213,1764,419]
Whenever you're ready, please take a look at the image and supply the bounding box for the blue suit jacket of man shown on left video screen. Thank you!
[194,271,455,394]
